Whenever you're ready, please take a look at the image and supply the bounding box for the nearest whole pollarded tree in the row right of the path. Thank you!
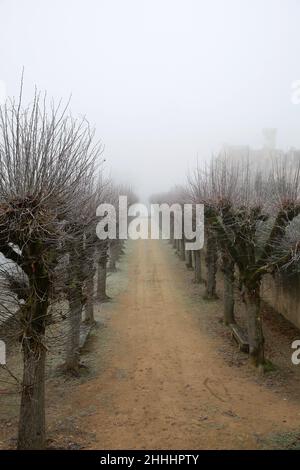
[207,156,300,366]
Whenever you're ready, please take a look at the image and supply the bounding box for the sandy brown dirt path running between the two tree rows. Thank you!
[69,240,300,449]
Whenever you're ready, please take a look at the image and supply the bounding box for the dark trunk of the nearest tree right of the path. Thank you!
[245,284,265,367]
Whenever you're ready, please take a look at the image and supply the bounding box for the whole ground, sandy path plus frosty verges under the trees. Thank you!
[0,240,300,449]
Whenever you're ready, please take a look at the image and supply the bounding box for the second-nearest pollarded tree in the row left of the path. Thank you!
[64,172,102,375]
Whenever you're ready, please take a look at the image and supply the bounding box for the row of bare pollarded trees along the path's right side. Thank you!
[152,152,300,370]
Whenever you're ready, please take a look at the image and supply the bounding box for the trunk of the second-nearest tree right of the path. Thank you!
[222,253,235,325]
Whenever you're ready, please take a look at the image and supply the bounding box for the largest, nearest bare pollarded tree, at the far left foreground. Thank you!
[0,89,98,449]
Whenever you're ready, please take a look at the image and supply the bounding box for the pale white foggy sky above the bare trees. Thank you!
[0,0,300,197]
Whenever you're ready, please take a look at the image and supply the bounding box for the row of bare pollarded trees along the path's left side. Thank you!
[0,93,133,449]
